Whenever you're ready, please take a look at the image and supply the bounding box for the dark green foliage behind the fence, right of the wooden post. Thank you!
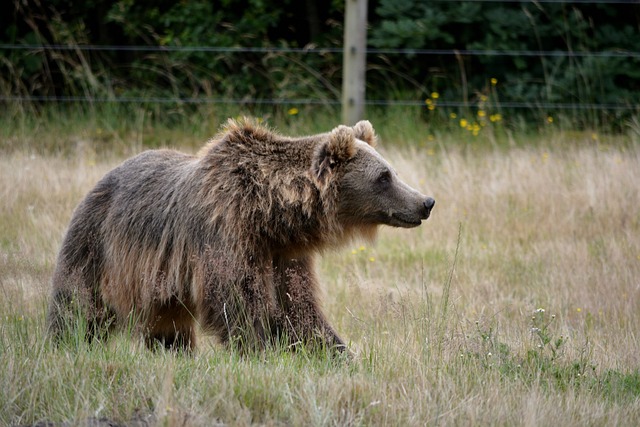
[369,0,640,126]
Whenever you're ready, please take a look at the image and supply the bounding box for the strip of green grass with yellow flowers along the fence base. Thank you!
[0,103,640,156]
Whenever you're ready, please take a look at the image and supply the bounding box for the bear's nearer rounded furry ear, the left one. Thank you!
[311,125,356,185]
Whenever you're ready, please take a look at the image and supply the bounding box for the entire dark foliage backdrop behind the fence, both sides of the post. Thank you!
[0,0,640,128]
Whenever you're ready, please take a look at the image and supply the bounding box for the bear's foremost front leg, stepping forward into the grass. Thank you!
[274,258,346,352]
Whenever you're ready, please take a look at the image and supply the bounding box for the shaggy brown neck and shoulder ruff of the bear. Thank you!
[196,137,351,256]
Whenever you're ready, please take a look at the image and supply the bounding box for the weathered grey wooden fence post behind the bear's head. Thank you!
[342,0,367,125]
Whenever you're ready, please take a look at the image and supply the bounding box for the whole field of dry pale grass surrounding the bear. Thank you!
[0,118,640,426]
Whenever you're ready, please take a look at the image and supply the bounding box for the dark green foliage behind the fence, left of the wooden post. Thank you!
[0,0,342,100]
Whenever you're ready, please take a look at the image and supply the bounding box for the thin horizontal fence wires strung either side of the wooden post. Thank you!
[0,44,640,111]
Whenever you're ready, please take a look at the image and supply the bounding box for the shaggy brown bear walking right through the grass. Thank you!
[48,119,435,351]
